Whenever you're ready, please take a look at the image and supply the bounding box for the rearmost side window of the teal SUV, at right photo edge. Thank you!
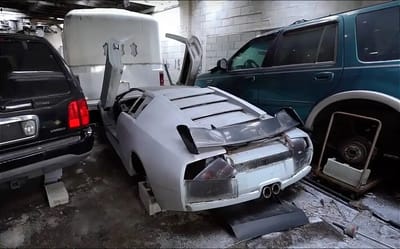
[356,7,400,61]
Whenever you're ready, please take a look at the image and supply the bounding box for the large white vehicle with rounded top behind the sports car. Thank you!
[62,8,164,110]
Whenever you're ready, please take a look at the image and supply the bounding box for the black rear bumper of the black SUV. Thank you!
[0,128,94,183]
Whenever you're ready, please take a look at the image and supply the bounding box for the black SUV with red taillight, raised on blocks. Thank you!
[0,34,94,186]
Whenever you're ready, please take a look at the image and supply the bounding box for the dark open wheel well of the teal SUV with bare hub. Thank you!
[312,101,400,167]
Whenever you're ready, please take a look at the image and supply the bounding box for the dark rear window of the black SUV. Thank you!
[0,38,70,99]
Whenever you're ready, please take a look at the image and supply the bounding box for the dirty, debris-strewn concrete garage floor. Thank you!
[0,135,400,248]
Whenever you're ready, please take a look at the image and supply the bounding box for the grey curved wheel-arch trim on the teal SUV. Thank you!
[305,90,400,130]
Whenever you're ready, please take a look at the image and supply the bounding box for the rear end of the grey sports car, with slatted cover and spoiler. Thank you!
[167,88,313,211]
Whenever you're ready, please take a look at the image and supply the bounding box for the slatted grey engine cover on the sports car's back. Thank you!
[141,86,265,127]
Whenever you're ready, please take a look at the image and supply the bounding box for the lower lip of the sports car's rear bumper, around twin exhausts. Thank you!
[186,166,311,211]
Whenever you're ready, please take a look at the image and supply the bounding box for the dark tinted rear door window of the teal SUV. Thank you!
[273,23,337,66]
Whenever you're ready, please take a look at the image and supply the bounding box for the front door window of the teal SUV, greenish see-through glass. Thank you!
[230,34,276,70]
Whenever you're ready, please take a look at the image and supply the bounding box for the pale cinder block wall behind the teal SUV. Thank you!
[154,0,386,83]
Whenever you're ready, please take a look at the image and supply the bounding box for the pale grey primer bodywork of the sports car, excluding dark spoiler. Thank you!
[107,87,312,211]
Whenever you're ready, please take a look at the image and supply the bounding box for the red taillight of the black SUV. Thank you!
[68,99,89,129]
